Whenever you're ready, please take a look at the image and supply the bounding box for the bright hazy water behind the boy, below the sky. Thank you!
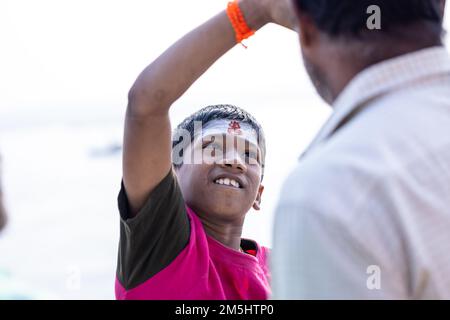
[0,99,329,299]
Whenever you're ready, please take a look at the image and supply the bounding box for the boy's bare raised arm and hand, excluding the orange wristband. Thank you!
[123,0,293,216]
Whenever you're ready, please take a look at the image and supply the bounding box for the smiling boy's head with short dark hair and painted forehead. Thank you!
[172,105,266,221]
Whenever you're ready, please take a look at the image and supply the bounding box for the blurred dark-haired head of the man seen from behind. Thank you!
[293,0,445,104]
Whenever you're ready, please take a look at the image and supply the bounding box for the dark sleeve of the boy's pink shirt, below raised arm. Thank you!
[117,169,190,290]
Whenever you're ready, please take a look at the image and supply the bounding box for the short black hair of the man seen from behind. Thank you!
[294,0,443,36]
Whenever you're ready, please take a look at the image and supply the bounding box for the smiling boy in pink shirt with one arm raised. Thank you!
[116,0,294,299]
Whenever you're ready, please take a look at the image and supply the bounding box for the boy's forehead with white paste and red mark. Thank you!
[194,120,259,147]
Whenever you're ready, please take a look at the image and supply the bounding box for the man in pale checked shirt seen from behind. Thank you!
[272,0,450,299]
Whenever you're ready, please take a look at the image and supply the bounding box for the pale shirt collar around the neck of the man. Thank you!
[302,46,450,157]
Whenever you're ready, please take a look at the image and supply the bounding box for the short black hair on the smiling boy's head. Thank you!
[172,104,266,176]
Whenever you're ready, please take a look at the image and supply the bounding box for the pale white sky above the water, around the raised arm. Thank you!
[0,0,449,124]
